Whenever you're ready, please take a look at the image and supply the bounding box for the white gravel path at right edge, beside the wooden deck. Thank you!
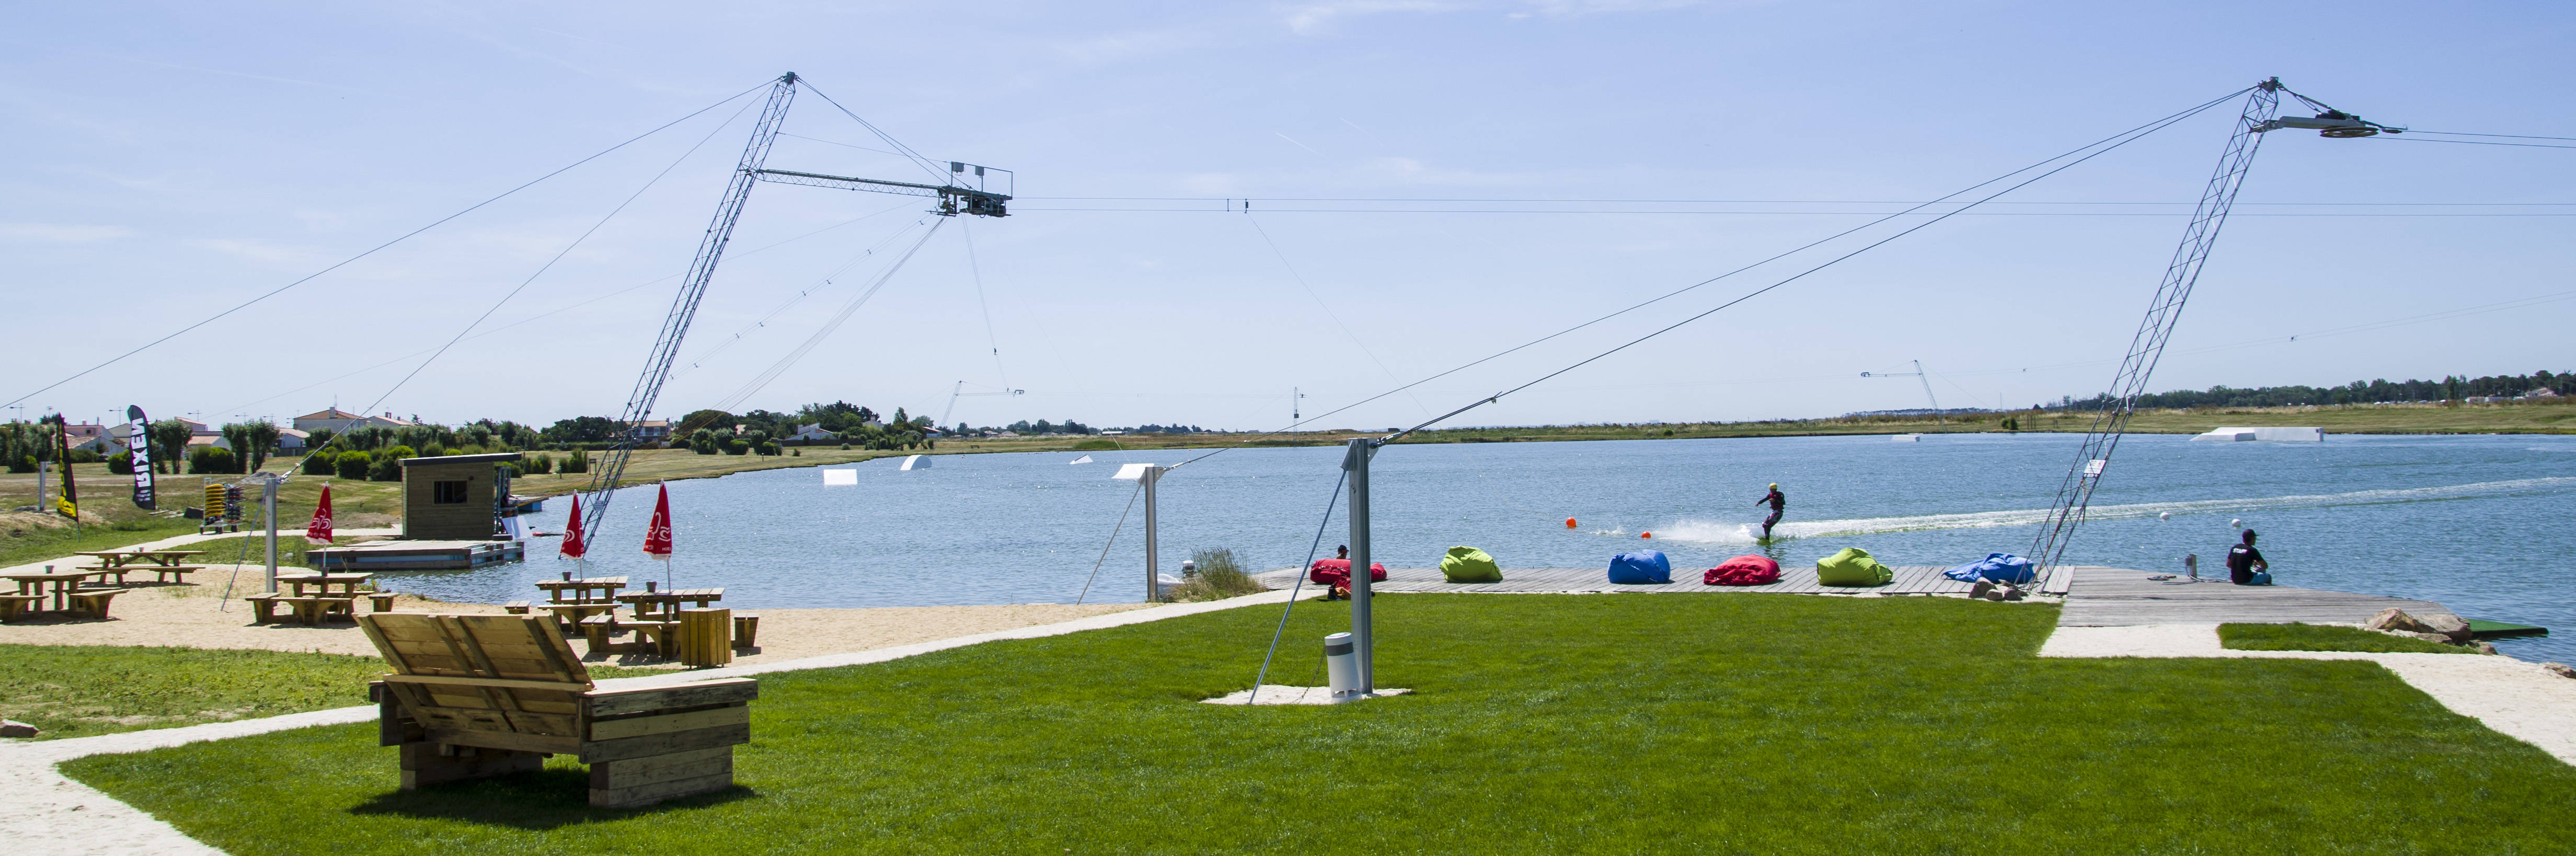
[2040,624,2576,763]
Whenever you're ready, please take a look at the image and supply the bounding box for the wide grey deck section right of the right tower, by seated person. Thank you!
[2058,567,2450,627]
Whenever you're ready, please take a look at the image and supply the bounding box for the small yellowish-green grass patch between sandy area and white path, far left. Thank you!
[0,644,649,740]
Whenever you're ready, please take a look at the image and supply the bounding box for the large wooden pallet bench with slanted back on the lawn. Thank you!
[358,614,760,807]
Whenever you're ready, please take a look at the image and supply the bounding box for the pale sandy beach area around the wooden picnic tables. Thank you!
[0,583,1149,665]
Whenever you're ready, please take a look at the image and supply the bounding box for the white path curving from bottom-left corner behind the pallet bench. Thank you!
[0,591,1319,856]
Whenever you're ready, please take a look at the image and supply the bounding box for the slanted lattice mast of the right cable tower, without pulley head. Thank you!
[2030,77,2295,570]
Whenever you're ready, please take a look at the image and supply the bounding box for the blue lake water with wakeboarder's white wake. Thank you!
[386,433,2576,660]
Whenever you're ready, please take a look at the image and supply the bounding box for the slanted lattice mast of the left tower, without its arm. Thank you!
[582,72,796,531]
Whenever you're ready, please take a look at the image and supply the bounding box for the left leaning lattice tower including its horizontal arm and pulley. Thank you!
[582,72,1015,531]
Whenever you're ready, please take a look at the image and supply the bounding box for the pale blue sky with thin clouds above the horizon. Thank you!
[0,0,2576,428]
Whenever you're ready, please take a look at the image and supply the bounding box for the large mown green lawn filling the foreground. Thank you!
[64,596,2576,853]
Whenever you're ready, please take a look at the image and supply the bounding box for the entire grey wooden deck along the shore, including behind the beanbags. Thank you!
[1257,564,2450,627]
